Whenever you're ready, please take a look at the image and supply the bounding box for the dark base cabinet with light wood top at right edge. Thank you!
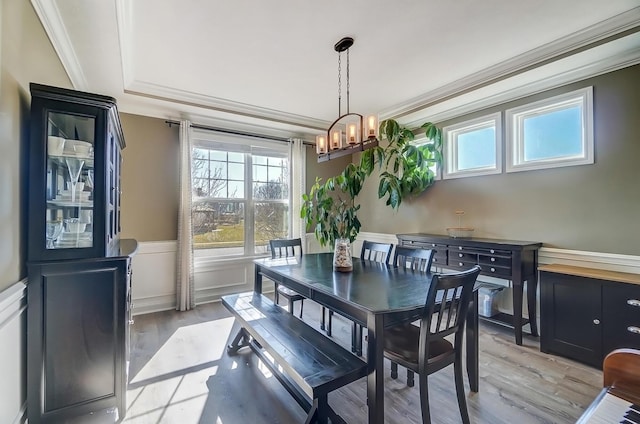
[540,265,640,368]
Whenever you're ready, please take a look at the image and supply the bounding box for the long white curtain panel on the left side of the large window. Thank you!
[176,121,196,311]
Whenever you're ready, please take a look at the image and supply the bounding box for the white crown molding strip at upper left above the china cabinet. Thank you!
[31,0,89,91]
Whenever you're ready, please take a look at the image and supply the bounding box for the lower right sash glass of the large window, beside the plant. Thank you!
[254,202,289,253]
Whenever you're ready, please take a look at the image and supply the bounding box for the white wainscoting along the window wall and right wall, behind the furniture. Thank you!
[133,232,640,315]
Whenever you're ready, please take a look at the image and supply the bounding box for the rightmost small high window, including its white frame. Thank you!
[506,87,593,172]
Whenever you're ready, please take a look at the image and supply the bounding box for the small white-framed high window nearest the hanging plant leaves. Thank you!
[442,113,502,179]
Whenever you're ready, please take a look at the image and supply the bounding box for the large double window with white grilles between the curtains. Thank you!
[191,133,290,258]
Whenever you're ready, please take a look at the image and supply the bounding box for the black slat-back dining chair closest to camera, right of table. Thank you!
[384,265,480,424]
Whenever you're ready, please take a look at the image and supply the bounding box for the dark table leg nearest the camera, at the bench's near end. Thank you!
[367,315,384,424]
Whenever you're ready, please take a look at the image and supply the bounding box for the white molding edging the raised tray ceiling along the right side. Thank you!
[380,7,640,120]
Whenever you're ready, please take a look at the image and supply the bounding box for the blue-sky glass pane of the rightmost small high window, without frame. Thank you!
[523,106,582,161]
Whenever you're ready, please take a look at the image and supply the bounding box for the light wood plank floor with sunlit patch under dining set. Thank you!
[125,300,602,424]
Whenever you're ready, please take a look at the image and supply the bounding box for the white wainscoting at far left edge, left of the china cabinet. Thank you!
[0,281,27,424]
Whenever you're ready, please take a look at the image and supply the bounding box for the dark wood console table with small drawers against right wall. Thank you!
[397,233,542,345]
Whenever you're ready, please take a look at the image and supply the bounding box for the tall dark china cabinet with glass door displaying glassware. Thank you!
[27,84,137,424]
